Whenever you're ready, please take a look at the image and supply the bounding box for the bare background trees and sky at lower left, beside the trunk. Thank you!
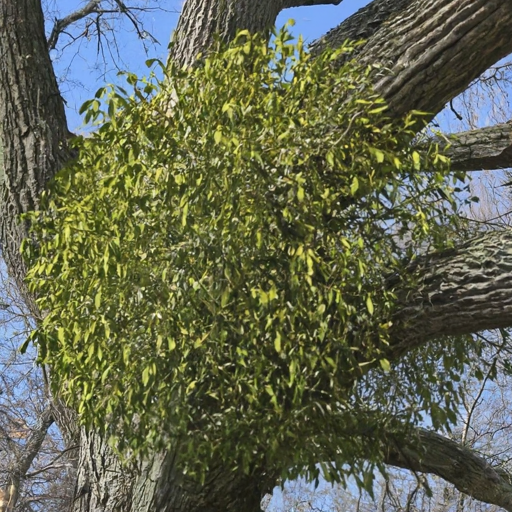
[0,260,76,512]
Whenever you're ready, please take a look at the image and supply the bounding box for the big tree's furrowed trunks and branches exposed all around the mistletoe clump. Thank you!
[0,0,512,512]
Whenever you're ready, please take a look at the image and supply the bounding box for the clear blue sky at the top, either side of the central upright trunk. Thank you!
[47,0,369,131]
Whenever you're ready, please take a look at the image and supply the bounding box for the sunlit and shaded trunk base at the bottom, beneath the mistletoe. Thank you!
[73,430,277,512]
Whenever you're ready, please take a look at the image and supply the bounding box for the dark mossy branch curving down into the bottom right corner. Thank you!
[385,429,512,512]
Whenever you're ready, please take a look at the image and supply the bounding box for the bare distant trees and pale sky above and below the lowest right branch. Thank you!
[265,332,511,512]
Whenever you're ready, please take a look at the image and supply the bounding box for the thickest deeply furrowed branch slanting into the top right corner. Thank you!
[312,0,512,116]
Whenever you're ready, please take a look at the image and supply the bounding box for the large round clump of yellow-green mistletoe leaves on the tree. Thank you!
[25,27,472,486]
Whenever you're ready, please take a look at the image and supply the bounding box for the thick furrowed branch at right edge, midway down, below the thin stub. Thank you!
[388,229,512,360]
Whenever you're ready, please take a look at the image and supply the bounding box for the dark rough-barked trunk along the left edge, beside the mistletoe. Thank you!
[0,0,70,314]
